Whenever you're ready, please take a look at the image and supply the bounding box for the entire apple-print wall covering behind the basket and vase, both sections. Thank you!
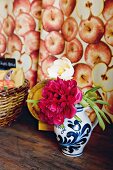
[0,0,113,120]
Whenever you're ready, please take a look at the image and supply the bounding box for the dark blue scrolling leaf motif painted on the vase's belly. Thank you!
[57,118,91,153]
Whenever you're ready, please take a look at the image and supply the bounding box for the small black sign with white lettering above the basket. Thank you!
[0,58,16,70]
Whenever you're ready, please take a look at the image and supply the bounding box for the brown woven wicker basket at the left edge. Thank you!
[0,80,29,126]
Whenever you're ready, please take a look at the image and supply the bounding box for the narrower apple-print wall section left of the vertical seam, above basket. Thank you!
[0,0,42,87]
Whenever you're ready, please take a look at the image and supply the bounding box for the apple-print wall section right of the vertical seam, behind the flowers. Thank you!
[38,0,113,120]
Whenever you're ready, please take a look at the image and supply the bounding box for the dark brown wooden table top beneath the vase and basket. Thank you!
[0,108,113,170]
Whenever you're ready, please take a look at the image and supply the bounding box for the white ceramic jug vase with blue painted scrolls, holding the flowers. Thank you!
[54,105,98,157]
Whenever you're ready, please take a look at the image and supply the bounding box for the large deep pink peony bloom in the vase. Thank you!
[38,78,82,125]
